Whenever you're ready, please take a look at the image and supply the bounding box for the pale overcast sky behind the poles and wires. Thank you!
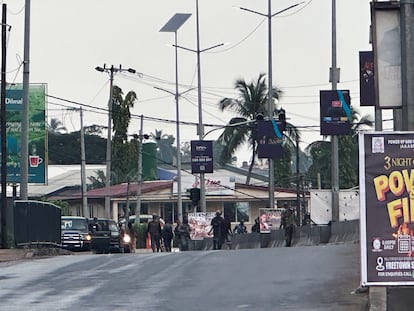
[1,0,386,162]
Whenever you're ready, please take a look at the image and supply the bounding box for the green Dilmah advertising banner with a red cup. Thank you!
[6,84,47,184]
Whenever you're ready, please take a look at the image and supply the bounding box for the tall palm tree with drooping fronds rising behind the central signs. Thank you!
[218,73,299,184]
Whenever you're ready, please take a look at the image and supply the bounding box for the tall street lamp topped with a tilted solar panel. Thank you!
[160,13,191,222]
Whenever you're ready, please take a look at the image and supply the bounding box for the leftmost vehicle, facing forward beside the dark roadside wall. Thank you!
[61,216,92,251]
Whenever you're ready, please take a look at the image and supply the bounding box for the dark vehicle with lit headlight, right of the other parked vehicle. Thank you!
[88,218,122,254]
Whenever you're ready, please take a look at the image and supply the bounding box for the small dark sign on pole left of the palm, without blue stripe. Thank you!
[191,140,213,174]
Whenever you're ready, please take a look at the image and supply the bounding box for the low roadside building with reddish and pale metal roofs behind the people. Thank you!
[38,166,309,232]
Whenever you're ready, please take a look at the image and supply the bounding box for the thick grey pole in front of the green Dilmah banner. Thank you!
[20,0,30,200]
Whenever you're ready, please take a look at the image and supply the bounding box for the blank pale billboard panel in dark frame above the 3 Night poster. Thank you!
[371,1,402,108]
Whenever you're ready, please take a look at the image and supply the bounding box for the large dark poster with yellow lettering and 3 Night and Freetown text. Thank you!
[359,132,414,285]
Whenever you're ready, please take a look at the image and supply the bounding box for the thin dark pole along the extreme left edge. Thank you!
[0,3,7,248]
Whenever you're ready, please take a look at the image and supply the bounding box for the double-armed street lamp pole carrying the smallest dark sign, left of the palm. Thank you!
[174,0,224,212]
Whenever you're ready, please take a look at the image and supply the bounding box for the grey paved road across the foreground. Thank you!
[0,245,368,311]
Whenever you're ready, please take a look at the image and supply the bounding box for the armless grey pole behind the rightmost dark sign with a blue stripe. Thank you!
[330,0,339,221]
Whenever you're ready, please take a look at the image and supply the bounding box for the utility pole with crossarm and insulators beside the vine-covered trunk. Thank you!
[95,64,136,218]
